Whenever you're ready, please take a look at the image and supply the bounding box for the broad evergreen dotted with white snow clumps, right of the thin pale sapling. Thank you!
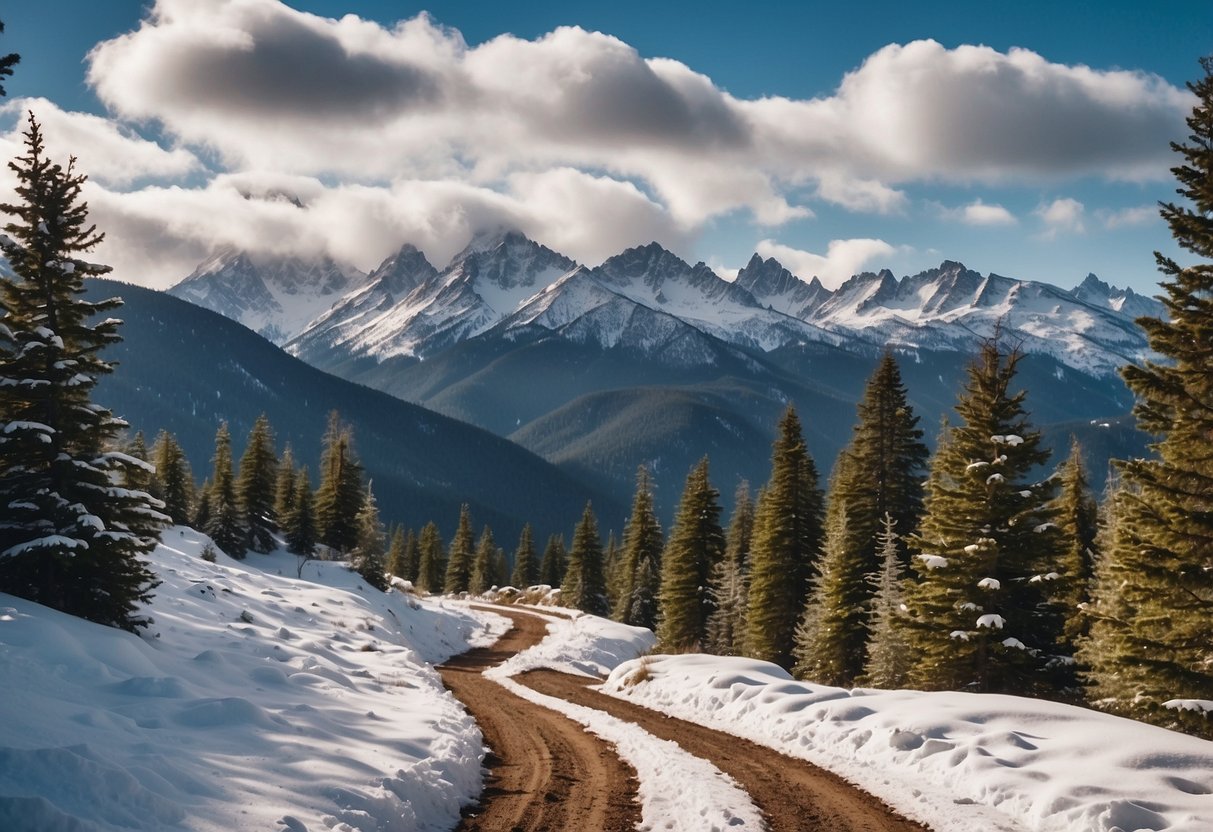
[906,341,1061,694]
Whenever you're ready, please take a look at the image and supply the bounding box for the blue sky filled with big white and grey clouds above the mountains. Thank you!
[0,0,1213,292]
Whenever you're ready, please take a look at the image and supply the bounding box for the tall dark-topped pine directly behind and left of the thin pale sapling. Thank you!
[802,351,928,686]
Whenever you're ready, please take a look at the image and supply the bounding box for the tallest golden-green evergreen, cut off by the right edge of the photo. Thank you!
[1087,56,1213,736]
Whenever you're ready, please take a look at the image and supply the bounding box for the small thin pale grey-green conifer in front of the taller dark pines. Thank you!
[861,514,910,690]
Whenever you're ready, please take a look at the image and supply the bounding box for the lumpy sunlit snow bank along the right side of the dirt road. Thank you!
[603,655,1213,832]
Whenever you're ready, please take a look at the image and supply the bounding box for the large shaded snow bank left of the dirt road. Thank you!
[0,528,494,832]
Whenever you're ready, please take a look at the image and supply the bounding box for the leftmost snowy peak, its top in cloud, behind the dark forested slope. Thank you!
[169,247,366,344]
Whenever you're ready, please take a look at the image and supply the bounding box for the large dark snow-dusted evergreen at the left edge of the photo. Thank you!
[0,114,169,629]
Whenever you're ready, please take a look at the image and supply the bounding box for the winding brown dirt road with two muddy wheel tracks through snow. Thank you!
[439,609,924,832]
